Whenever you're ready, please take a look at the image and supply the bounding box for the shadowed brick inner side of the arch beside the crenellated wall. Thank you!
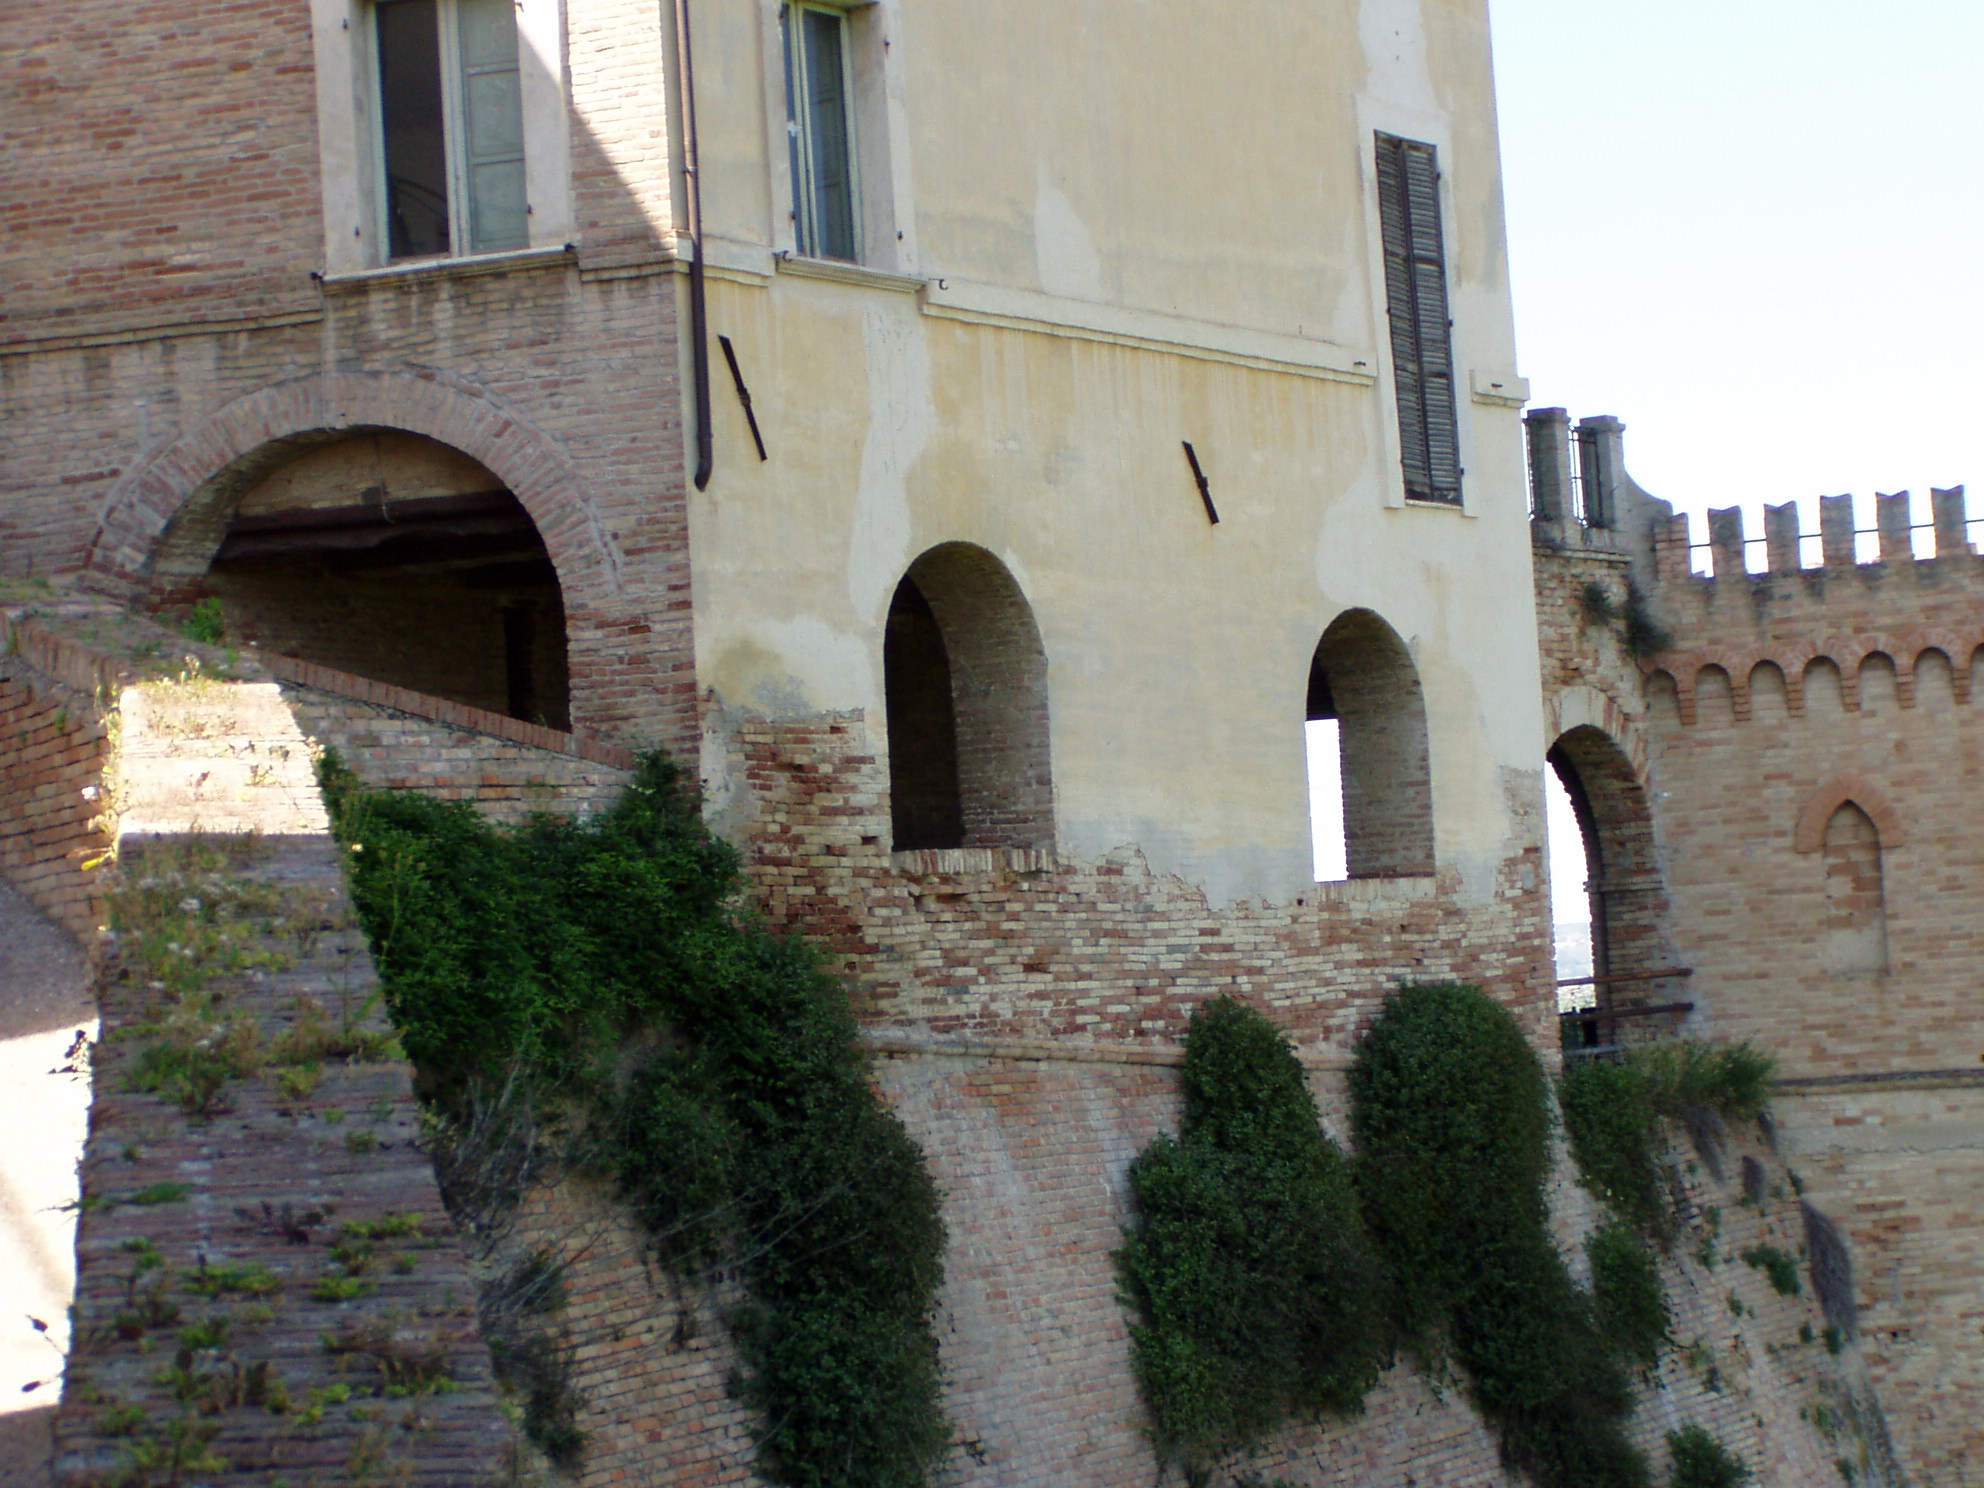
[1546,726,1674,1031]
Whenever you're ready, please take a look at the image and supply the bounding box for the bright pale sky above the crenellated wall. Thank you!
[1490,0,1984,554]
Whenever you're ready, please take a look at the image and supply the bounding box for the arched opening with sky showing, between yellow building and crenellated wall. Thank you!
[1544,726,1676,1040]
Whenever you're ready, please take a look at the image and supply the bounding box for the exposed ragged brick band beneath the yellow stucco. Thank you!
[734,714,1555,1057]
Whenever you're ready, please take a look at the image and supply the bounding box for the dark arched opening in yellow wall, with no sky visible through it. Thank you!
[883,542,1054,851]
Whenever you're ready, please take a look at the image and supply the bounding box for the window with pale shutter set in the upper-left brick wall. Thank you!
[375,0,530,258]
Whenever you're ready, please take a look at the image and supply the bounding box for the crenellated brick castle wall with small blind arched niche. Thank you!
[1538,480,1984,1484]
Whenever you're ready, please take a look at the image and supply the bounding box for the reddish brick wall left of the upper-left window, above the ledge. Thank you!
[0,0,323,339]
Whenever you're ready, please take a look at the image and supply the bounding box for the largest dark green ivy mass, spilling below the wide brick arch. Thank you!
[321,754,950,1488]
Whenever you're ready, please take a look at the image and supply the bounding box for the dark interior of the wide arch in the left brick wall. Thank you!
[177,429,571,728]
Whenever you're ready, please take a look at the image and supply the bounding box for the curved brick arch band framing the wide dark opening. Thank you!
[85,373,621,611]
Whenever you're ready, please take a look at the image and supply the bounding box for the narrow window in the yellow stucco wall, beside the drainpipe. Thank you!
[780,4,857,262]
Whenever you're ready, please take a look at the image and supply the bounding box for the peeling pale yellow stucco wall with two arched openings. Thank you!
[679,0,1542,901]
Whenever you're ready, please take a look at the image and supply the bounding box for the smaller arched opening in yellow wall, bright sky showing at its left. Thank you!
[1303,609,1432,883]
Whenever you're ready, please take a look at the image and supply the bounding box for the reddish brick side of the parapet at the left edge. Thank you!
[0,617,113,946]
